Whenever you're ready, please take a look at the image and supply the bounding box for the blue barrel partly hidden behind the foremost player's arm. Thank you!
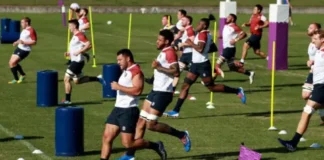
[102,64,121,98]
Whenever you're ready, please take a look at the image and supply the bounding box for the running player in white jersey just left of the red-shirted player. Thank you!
[215,14,254,84]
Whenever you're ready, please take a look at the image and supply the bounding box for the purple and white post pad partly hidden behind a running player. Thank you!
[219,0,237,55]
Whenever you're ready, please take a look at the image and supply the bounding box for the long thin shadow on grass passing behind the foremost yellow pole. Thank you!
[178,110,302,119]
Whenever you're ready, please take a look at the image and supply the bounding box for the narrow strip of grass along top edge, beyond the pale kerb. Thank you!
[0,0,324,7]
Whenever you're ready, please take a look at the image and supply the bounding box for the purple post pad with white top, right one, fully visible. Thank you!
[268,0,289,70]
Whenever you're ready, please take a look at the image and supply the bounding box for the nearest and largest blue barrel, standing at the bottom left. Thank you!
[55,107,84,156]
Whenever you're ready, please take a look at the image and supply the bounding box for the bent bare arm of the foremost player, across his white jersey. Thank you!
[112,73,144,96]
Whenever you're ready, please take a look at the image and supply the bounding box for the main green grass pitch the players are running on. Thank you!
[0,14,324,160]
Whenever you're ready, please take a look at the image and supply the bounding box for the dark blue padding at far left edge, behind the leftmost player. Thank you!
[1,18,20,43]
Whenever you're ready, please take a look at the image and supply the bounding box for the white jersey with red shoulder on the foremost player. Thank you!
[115,64,143,108]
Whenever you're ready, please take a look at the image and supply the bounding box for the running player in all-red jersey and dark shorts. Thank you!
[241,4,269,64]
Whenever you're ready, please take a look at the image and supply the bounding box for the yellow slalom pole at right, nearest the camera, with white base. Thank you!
[269,41,277,130]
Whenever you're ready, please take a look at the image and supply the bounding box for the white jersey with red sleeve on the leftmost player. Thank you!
[18,26,37,51]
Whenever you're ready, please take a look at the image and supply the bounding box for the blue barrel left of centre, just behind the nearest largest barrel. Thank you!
[37,70,58,107]
